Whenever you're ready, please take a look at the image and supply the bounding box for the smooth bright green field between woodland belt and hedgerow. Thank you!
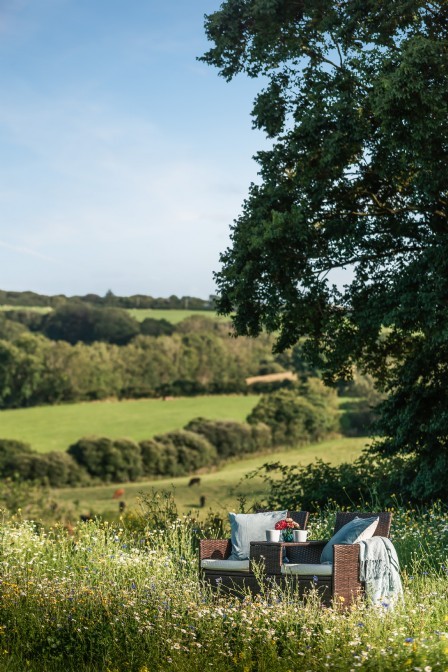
[0,395,259,453]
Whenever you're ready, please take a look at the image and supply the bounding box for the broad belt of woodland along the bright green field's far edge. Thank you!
[0,318,290,408]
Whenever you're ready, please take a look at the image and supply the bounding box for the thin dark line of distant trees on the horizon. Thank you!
[0,289,215,310]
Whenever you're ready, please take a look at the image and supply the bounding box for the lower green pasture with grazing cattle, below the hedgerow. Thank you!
[55,437,367,517]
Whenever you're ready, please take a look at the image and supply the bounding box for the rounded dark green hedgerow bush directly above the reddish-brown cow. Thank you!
[67,436,143,483]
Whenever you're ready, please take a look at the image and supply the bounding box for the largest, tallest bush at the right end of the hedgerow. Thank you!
[247,390,337,445]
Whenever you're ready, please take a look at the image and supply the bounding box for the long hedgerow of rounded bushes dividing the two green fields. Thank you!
[0,380,337,487]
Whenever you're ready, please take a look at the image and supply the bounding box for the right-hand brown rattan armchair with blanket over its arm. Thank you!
[250,512,392,606]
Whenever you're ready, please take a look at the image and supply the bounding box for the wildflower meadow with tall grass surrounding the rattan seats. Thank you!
[0,496,448,672]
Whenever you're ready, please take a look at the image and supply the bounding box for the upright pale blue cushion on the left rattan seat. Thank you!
[229,511,288,560]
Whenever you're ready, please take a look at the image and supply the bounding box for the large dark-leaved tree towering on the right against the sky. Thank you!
[202,0,448,497]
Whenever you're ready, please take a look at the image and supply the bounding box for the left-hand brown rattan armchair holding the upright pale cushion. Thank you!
[199,511,309,594]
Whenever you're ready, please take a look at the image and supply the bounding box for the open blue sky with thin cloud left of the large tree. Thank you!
[0,0,266,298]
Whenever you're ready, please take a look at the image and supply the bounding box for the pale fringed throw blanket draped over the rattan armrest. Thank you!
[359,537,403,606]
